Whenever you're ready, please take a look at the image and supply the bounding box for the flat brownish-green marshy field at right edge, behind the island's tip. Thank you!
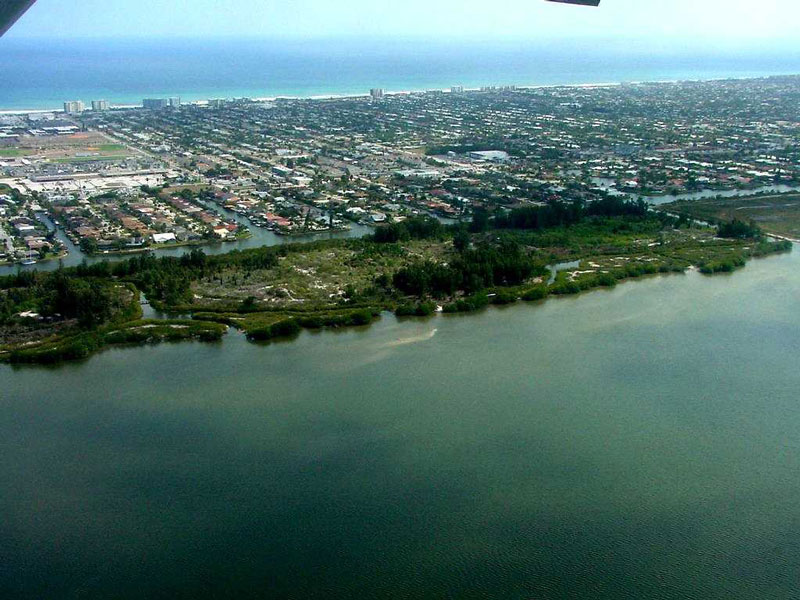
[663,194,800,240]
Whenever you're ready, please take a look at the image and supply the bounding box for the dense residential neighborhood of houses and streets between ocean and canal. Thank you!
[0,77,800,261]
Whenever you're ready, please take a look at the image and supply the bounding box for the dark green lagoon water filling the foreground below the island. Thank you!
[0,247,800,600]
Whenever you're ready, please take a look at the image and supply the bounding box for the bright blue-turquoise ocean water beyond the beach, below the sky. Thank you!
[0,37,800,109]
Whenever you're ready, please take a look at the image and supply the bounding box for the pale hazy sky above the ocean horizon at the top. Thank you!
[8,0,800,45]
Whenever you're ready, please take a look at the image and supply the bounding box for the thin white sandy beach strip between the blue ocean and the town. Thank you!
[0,72,800,116]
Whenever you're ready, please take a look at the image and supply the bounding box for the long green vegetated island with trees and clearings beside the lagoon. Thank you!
[0,197,792,363]
